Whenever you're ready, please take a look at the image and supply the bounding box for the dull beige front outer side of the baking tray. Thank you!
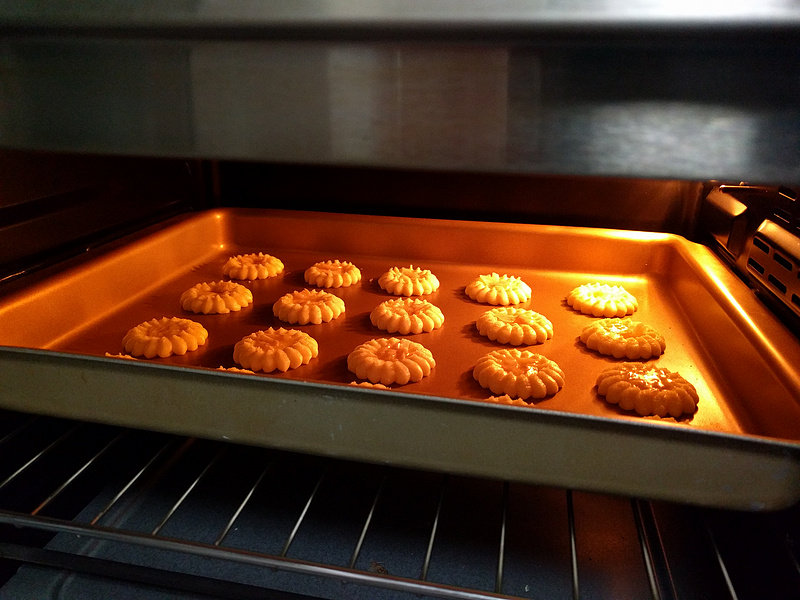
[0,347,800,511]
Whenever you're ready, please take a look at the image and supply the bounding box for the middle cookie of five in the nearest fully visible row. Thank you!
[347,337,436,385]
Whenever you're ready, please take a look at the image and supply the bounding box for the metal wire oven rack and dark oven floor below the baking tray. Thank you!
[0,412,800,600]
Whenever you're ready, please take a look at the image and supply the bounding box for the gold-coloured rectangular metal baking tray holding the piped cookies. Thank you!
[0,209,800,510]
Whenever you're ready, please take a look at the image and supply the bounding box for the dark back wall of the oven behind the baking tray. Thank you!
[215,162,704,237]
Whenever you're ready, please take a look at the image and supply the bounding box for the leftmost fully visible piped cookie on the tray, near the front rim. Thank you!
[122,317,208,358]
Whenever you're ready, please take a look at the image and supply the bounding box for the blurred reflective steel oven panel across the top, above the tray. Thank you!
[0,0,800,184]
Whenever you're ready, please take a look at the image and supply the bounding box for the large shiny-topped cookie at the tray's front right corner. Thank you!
[597,363,699,418]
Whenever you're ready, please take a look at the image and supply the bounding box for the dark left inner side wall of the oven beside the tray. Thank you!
[0,150,203,283]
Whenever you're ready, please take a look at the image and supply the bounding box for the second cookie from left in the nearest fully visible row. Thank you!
[233,327,319,373]
